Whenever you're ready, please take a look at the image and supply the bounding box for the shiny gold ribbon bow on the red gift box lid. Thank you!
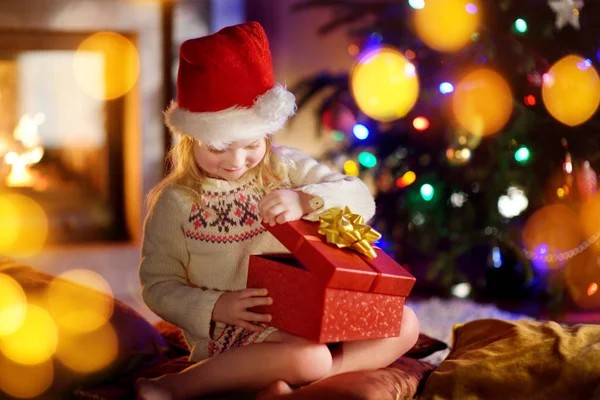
[319,207,381,258]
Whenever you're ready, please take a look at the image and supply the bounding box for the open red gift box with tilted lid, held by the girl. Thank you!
[248,220,415,343]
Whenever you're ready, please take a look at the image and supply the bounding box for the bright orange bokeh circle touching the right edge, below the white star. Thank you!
[542,55,600,126]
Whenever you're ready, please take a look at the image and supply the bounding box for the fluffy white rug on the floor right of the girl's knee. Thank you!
[406,297,534,365]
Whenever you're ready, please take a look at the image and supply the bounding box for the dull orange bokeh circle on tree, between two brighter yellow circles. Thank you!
[452,68,513,136]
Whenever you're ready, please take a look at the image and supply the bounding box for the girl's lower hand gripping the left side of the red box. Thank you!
[212,289,273,332]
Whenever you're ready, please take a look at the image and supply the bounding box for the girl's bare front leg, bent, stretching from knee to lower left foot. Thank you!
[136,335,332,400]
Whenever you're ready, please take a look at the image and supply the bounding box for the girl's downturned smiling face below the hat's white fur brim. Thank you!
[194,137,267,181]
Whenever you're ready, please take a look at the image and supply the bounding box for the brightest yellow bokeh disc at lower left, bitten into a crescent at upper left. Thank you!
[0,304,58,365]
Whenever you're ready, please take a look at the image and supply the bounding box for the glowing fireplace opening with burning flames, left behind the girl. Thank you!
[0,30,134,245]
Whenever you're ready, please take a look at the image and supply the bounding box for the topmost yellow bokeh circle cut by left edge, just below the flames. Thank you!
[0,193,48,257]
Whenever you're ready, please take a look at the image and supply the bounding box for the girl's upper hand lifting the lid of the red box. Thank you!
[258,189,312,226]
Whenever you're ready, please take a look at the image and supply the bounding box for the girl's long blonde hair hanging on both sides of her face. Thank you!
[147,135,287,214]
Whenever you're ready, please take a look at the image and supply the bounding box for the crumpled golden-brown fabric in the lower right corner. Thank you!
[421,319,600,400]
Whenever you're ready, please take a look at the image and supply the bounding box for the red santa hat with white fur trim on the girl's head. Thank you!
[165,22,296,148]
